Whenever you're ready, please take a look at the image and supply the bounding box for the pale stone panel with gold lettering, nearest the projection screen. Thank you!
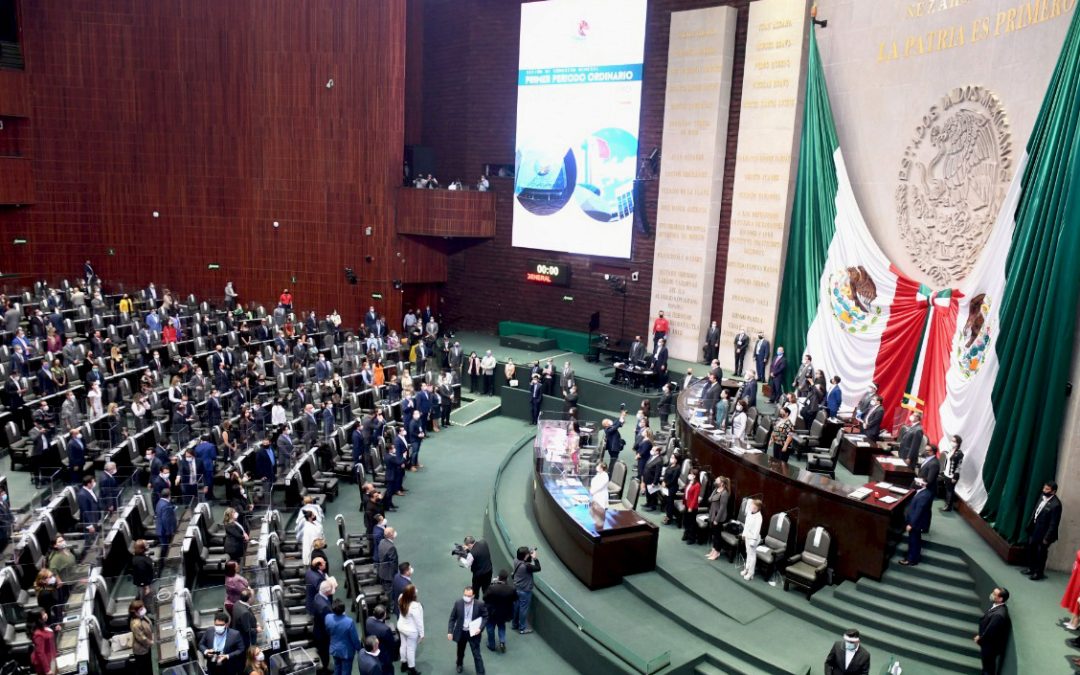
[650,8,739,361]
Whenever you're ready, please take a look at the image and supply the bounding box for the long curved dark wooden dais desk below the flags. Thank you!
[678,382,912,581]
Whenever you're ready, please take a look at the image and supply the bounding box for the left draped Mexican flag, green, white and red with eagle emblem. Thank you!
[777,30,929,428]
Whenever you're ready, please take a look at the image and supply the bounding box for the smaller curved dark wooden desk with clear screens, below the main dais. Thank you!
[532,419,660,590]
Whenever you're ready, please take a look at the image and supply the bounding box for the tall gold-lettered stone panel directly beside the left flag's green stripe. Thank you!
[720,0,809,369]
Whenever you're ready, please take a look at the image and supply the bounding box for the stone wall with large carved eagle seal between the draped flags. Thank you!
[816,0,1077,288]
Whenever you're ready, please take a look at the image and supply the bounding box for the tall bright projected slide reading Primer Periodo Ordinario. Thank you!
[513,0,646,258]
